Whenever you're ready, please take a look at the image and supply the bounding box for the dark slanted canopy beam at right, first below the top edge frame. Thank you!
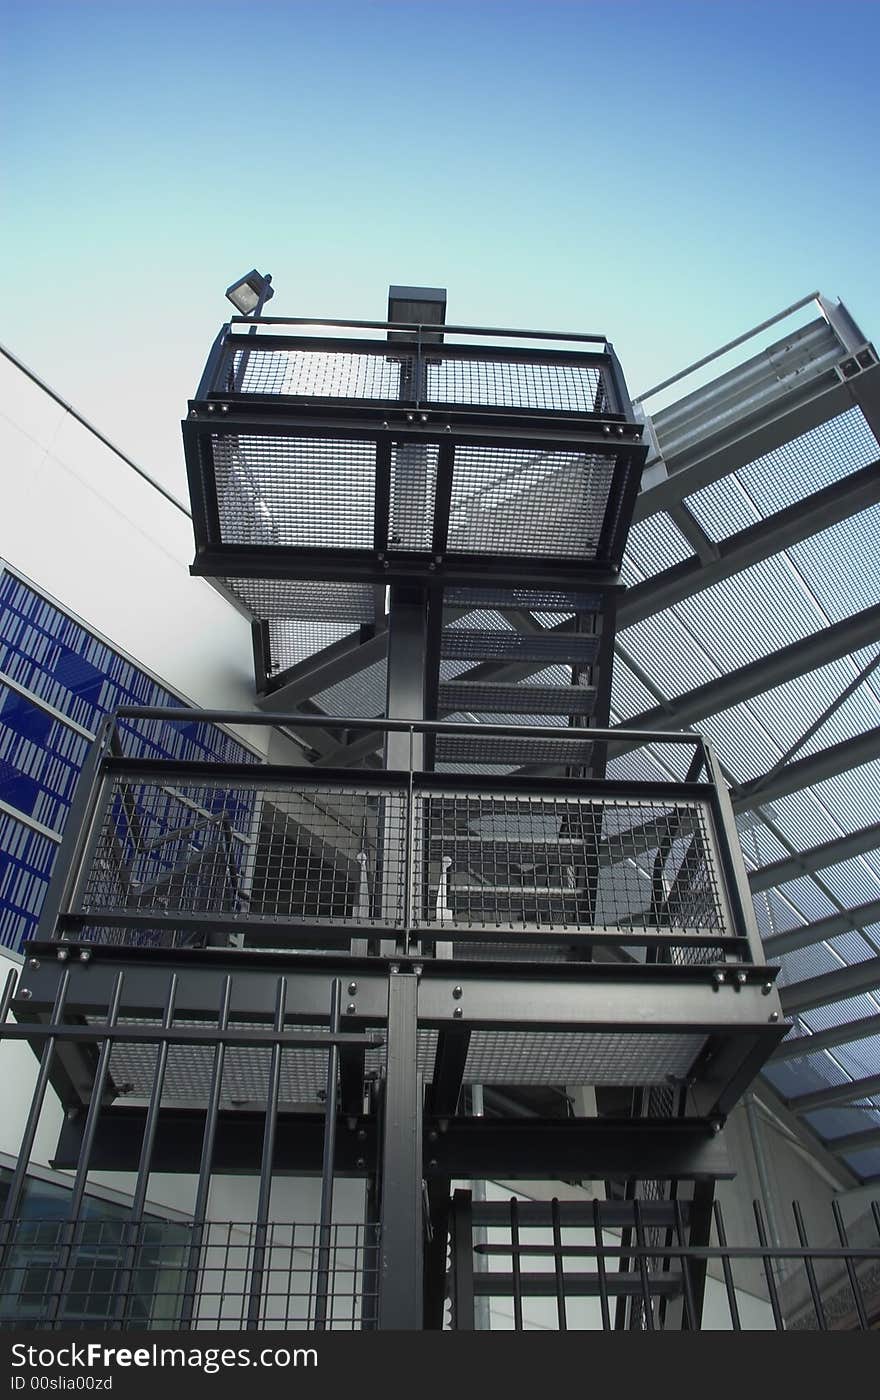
[617,462,880,631]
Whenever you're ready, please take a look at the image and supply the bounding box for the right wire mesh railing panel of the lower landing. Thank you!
[416,788,732,960]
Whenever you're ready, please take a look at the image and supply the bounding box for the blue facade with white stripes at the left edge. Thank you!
[0,573,257,949]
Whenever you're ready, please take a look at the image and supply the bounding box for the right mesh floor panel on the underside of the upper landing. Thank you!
[448,445,616,559]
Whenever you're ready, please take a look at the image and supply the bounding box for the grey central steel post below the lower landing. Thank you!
[379,973,424,1331]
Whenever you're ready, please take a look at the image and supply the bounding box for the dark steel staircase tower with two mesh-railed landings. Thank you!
[6,288,786,1329]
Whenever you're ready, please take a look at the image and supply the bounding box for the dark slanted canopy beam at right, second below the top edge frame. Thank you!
[616,605,880,753]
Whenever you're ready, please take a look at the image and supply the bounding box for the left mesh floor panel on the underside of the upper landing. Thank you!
[211,434,375,549]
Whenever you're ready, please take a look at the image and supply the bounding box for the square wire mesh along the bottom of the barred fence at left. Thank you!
[0,1218,378,1331]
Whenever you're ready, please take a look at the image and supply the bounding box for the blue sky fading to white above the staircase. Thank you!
[0,0,880,495]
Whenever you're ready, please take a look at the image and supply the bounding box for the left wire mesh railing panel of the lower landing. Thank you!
[77,773,406,946]
